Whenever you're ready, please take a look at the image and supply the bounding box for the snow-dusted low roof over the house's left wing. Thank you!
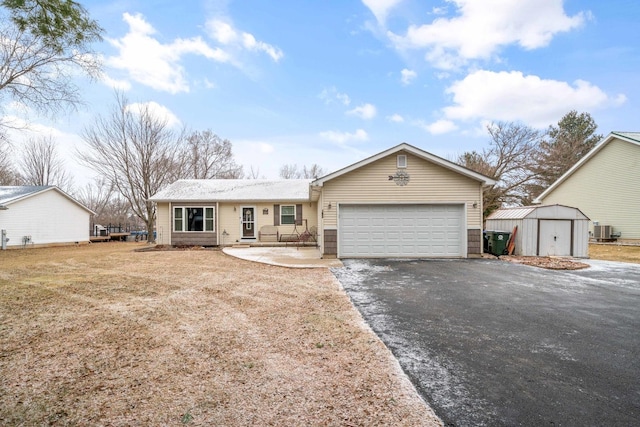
[149,179,311,202]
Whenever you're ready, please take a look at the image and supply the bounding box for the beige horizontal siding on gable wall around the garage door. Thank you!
[321,152,482,229]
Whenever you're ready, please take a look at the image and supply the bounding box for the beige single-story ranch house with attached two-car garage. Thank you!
[150,144,495,258]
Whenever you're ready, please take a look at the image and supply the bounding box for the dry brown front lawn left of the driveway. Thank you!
[0,243,439,426]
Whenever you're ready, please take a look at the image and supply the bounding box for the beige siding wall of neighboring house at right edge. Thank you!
[542,139,640,239]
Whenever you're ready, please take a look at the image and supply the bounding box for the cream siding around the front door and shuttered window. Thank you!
[218,201,318,245]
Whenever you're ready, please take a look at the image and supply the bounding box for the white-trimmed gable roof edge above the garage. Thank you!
[311,143,496,186]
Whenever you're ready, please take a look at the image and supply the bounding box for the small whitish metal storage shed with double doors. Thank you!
[485,205,589,258]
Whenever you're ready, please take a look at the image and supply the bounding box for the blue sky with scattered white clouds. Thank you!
[6,0,640,179]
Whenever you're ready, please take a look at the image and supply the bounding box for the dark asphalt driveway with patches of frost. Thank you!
[332,259,640,426]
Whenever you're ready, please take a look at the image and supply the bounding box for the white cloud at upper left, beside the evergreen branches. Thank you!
[106,13,230,94]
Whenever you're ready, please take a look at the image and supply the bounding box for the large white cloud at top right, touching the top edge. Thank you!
[387,0,589,69]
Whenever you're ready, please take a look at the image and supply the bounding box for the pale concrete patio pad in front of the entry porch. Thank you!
[222,247,343,268]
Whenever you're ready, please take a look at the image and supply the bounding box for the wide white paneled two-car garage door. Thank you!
[338,204,466,258]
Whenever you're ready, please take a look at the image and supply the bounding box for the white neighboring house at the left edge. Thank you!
[0,185,93,248]
